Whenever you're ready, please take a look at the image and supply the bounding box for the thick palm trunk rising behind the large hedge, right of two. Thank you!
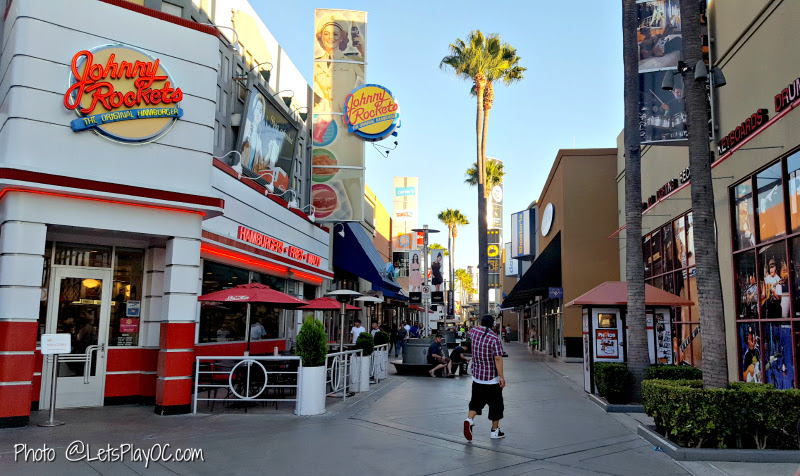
[681,2,728,388]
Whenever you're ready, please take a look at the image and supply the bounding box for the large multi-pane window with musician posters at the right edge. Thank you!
[730,153,800,388]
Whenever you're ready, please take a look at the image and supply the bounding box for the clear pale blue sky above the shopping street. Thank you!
[249,0,624,274]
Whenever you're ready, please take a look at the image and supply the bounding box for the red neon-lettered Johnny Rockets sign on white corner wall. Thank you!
[64,45,183,144]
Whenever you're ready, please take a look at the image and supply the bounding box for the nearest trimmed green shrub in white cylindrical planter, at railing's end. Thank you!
[297,315,328,415]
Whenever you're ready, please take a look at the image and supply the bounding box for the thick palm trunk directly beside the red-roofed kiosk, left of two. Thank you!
[622,0,650,401]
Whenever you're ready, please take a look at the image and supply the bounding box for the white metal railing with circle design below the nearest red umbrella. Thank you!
[192,356,303,413]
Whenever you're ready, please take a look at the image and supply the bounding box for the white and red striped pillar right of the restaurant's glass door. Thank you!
[155,238,200,415]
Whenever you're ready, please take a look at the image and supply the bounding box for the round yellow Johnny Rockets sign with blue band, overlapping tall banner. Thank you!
[344,84,400,141]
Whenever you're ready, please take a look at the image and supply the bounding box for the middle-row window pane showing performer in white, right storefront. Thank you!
[758,241,790,319]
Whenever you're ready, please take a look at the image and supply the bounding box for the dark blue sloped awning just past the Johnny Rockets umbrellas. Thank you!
[333,222,400,293]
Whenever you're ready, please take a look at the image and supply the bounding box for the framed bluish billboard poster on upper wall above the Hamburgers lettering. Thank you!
[237,87,298,190]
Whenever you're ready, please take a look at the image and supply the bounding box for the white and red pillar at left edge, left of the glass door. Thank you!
[0,221,47,428]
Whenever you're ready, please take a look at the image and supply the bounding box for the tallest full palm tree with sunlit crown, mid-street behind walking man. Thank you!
[439,30,525,314]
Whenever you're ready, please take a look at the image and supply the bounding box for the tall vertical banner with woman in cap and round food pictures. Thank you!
[311,9,367,222]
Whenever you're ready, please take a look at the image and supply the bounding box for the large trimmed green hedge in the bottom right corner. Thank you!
[642,379,800,449]
